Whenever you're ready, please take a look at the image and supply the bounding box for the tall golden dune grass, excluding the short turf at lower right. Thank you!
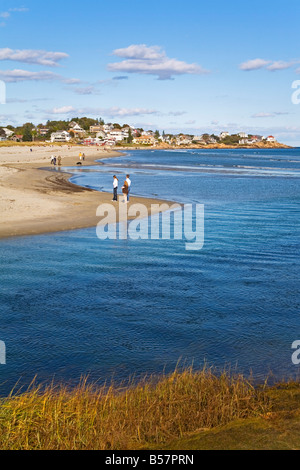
[0,368,270,450]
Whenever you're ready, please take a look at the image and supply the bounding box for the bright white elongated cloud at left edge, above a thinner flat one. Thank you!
[0,48,69,67]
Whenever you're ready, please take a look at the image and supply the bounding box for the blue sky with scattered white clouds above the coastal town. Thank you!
[0,0,300,145]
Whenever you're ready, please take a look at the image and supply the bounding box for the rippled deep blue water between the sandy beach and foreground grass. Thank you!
[0,149,300,393]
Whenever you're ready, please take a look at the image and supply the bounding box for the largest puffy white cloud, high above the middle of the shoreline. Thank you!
[108,44,208,80]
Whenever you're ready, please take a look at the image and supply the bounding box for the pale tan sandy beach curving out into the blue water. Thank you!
[0,146,172,238]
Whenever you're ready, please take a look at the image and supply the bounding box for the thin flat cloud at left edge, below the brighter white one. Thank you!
[0,69,80,85]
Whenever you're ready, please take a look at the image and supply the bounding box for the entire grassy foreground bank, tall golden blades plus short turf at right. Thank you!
[0,369,300,450]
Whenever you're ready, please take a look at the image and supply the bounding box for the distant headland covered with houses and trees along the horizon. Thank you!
[0,117,289,149]
